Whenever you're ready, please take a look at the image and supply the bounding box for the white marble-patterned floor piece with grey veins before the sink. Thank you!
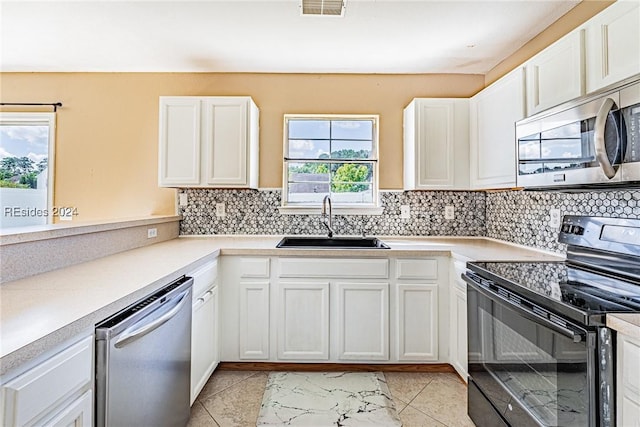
[257,372,402,427]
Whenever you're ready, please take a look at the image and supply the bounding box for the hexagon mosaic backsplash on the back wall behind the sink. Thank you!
[180,189,486,236]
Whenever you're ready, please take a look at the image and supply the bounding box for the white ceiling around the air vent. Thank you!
[0,0,579,74]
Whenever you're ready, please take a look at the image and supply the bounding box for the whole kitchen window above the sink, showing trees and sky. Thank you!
[282,114,381,214]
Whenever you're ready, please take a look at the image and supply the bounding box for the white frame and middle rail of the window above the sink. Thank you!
[280,114,382,215]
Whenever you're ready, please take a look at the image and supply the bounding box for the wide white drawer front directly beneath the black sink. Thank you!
[280,258,389,279]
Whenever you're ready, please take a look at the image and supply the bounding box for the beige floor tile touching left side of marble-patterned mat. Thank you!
[201,372,268,427]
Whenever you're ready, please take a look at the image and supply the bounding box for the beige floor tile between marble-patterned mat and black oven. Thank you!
[409,374,475,427]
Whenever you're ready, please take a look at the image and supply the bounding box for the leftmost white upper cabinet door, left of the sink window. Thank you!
[158,97,200,187]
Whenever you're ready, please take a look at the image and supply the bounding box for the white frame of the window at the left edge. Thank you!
[0,111,56,230]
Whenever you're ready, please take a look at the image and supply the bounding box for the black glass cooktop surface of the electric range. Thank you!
[468,261,640,325]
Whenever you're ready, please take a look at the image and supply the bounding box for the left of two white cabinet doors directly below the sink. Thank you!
[278,282,329,360]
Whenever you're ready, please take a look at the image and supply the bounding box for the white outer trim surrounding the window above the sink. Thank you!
[279,114,383,215]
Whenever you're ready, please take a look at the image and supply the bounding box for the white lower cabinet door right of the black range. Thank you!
[616,333,640,427]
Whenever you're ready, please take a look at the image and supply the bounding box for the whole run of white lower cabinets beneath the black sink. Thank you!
[220,256,448,363]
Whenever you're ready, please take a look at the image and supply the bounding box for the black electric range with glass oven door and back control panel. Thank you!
[463,216,640,427]
